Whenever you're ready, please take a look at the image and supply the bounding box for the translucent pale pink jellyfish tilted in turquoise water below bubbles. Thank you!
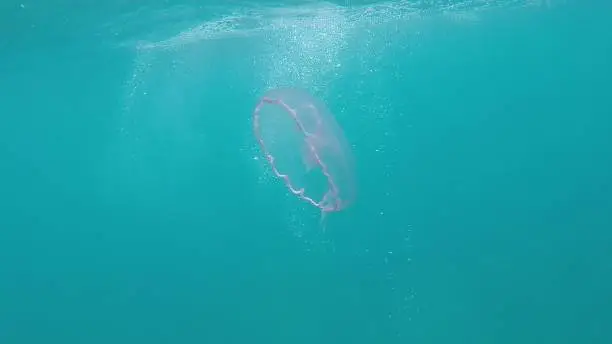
[253,88,355,214]
